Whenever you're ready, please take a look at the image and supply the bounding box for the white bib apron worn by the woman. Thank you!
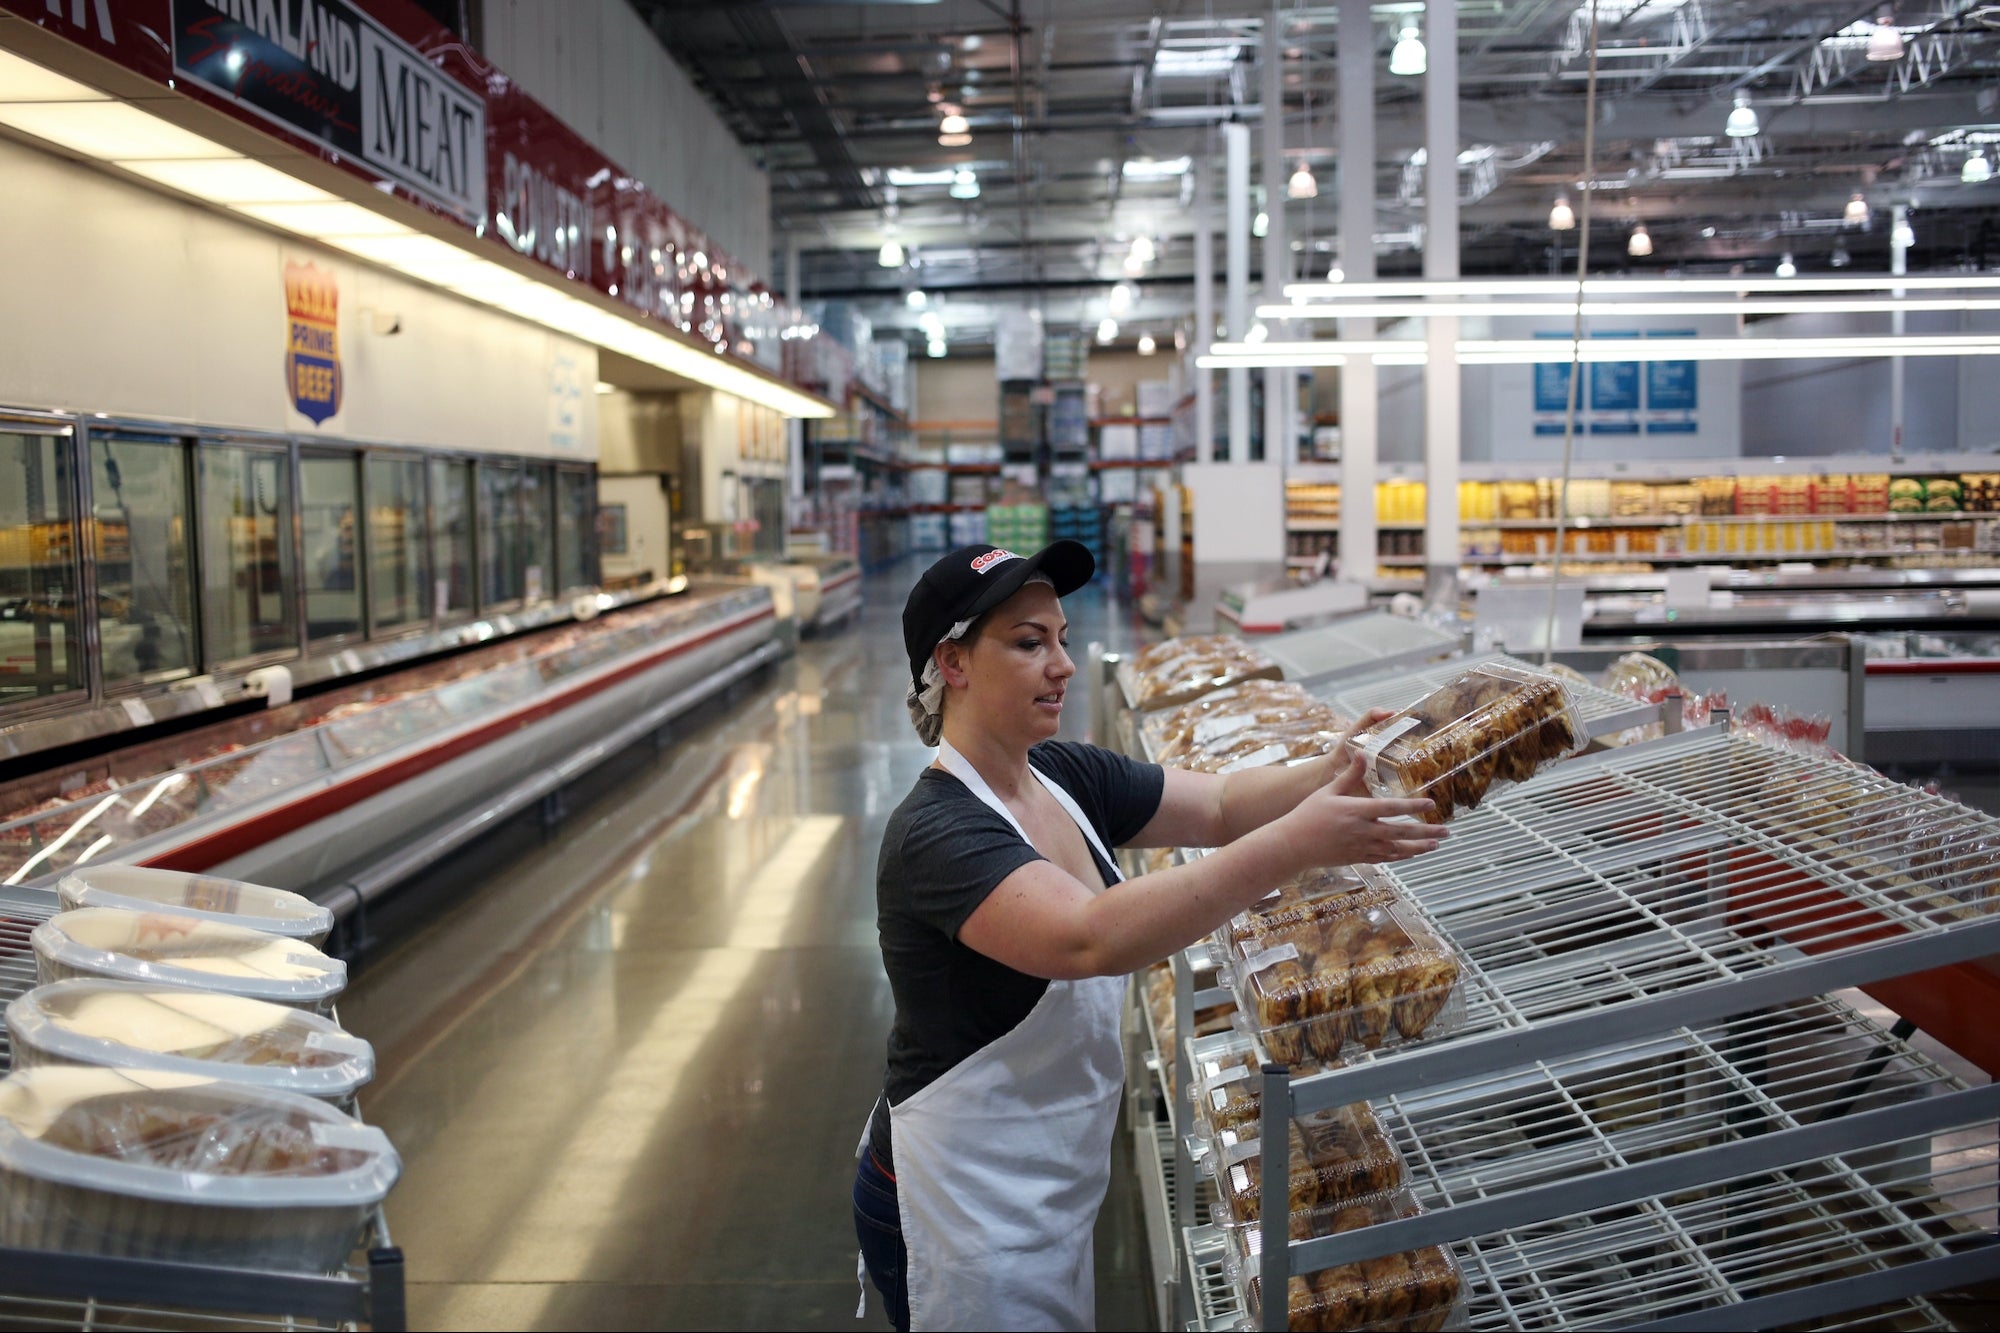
[890,743,1126,1331]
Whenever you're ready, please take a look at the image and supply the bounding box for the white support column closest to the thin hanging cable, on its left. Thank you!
[1424,0,1460,600]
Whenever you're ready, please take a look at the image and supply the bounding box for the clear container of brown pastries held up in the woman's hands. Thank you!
[1350,662,1590,825]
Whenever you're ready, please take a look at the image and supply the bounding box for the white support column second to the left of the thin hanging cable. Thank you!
[1338,0,1378,582]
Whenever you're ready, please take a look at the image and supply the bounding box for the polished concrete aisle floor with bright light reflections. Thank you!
[342,562,1150,1329]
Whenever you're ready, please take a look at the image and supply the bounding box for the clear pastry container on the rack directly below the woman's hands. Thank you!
[1230,903,1466,1067]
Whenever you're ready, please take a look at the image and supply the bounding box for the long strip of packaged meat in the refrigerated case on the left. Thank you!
[0,588,772,885]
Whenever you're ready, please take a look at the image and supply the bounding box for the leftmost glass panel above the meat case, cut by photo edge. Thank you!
[0,432,84,707]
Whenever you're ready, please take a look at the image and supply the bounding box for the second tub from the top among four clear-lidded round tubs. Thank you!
[28,907,348,1011]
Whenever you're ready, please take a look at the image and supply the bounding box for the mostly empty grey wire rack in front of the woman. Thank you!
[1232,727,2000,1329]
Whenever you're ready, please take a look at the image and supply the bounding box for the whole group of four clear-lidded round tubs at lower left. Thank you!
[0,867,402,1275]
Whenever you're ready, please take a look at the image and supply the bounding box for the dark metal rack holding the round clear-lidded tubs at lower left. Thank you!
[0,889,406,1333]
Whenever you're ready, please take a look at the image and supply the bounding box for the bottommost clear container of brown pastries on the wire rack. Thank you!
[1224,1191,1466,1333]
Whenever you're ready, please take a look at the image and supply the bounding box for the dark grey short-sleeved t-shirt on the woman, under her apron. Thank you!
[870,741,1166,1171]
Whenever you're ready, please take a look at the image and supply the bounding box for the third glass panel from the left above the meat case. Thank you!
[200,444,298,662]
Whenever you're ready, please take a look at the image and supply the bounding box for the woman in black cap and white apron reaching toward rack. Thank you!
[854,542,1444,1329]
